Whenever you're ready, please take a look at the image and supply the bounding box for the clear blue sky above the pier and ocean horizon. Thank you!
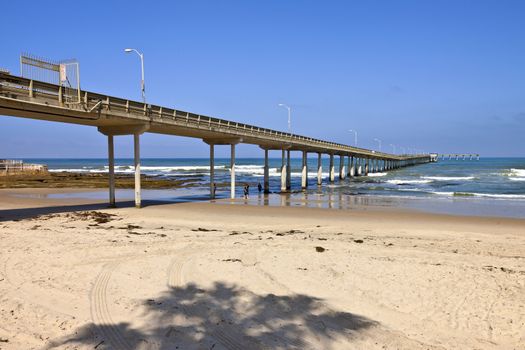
[0,0,525,158]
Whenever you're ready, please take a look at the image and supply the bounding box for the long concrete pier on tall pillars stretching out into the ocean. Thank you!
[0,73,430,207]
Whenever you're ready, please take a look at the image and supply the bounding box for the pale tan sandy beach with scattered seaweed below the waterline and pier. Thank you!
[0,190,525,350]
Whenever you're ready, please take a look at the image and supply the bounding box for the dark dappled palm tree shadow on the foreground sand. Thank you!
[47,283,377,350]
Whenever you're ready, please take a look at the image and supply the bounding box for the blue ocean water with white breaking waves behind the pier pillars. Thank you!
[24,156,525,217]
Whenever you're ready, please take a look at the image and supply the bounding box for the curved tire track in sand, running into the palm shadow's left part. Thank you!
[90,262,132,350]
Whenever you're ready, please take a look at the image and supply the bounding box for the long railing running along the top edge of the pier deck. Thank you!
[0,72,428,160]
